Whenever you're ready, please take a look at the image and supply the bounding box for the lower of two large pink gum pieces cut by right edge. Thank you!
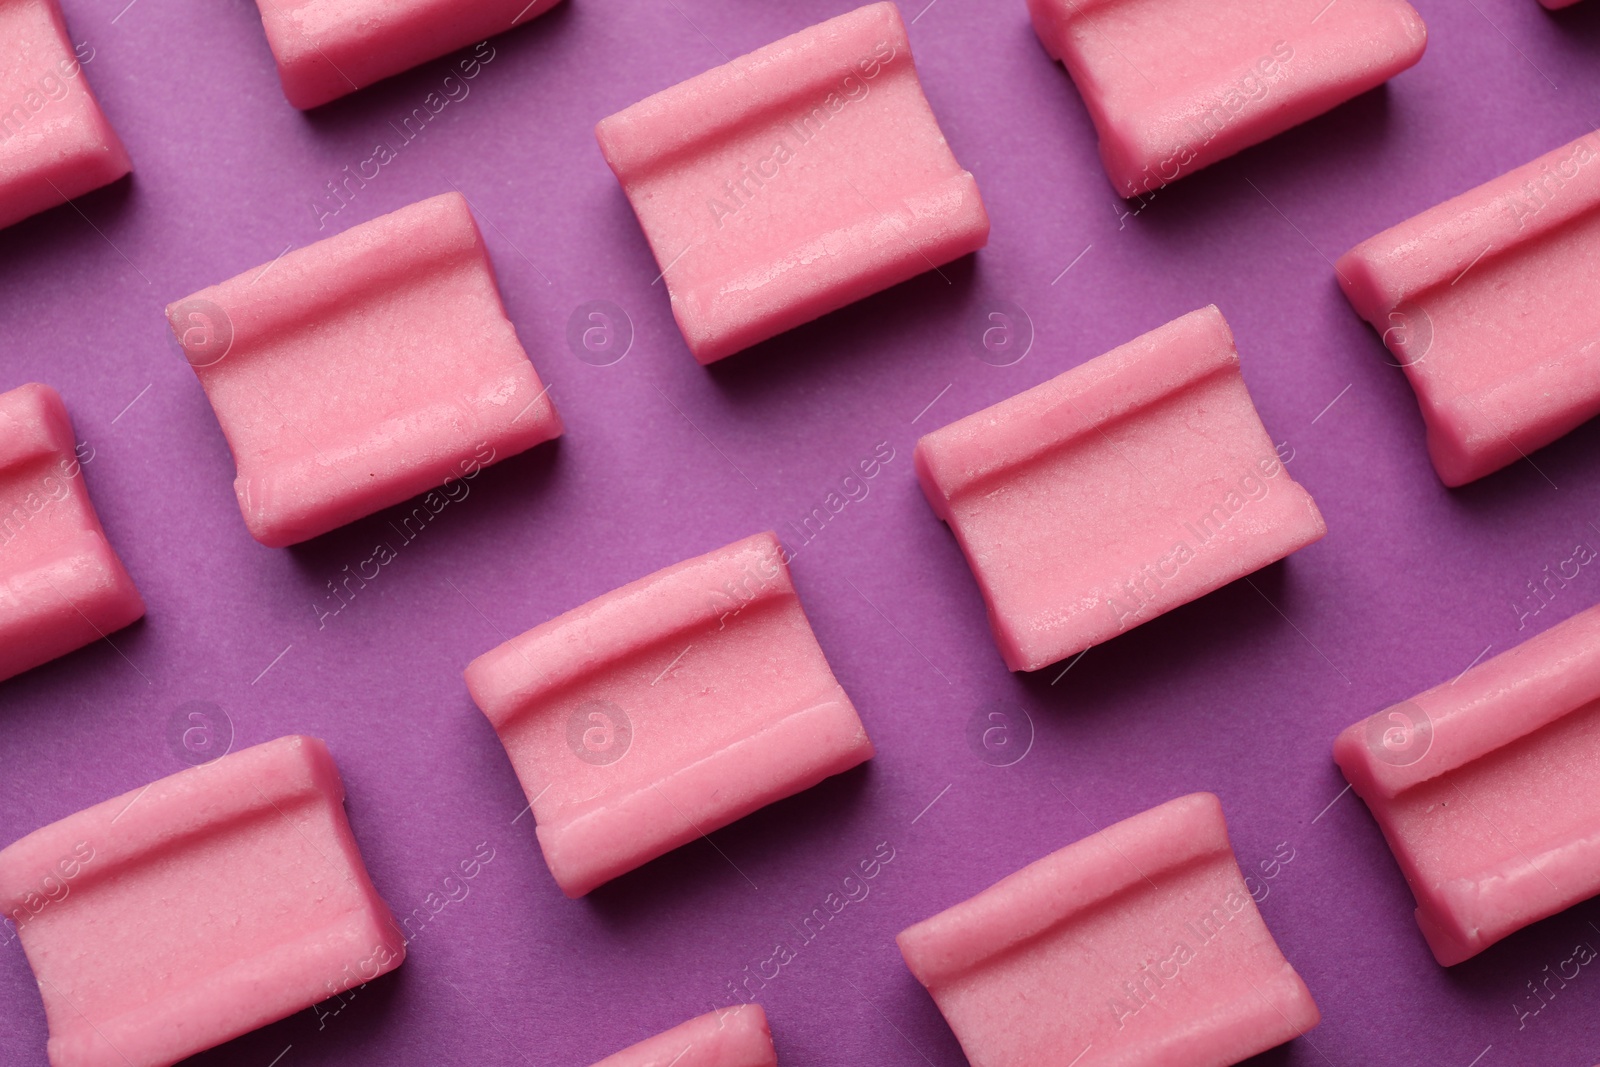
[1333,608,1600,966]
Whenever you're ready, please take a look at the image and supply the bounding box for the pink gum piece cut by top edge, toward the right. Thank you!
[1027,0,1427,197]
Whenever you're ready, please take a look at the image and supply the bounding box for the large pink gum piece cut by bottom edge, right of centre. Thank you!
[898,793,1322,1067]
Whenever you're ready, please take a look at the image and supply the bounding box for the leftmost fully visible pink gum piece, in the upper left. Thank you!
[166,192,562,547]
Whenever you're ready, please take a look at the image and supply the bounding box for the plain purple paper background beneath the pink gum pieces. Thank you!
[0,0,1600,1067]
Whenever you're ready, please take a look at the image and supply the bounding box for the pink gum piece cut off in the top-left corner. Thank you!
[0,0,133,229]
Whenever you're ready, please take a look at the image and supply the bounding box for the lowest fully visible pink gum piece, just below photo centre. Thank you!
[466,533,872,897]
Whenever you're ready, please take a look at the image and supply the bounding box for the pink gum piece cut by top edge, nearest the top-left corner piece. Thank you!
[256,0,560,109]
